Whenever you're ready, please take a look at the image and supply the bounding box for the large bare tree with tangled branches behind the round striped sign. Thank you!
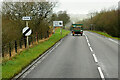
[2,0,56,44]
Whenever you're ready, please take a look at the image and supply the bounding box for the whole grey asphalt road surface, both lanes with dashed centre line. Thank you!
[23,31,118,80]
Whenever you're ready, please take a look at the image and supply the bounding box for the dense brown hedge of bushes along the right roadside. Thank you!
[79,9,120,37]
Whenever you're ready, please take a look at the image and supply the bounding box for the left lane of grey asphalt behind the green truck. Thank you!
[23,32,100,78]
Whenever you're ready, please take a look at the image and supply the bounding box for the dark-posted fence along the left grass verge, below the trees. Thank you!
[2,31,49,57]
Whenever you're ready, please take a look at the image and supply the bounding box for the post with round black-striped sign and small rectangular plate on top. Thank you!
[22,16,32,47]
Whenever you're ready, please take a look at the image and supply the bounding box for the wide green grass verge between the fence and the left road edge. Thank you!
[2,29,70,80]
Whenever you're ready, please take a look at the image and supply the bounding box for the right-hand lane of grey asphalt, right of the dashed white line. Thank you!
[85,32,119,78]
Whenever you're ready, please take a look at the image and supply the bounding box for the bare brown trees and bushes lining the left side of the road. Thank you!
[2,0,69,45]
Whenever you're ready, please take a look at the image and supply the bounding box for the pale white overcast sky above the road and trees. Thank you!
[54,0,119,14]
